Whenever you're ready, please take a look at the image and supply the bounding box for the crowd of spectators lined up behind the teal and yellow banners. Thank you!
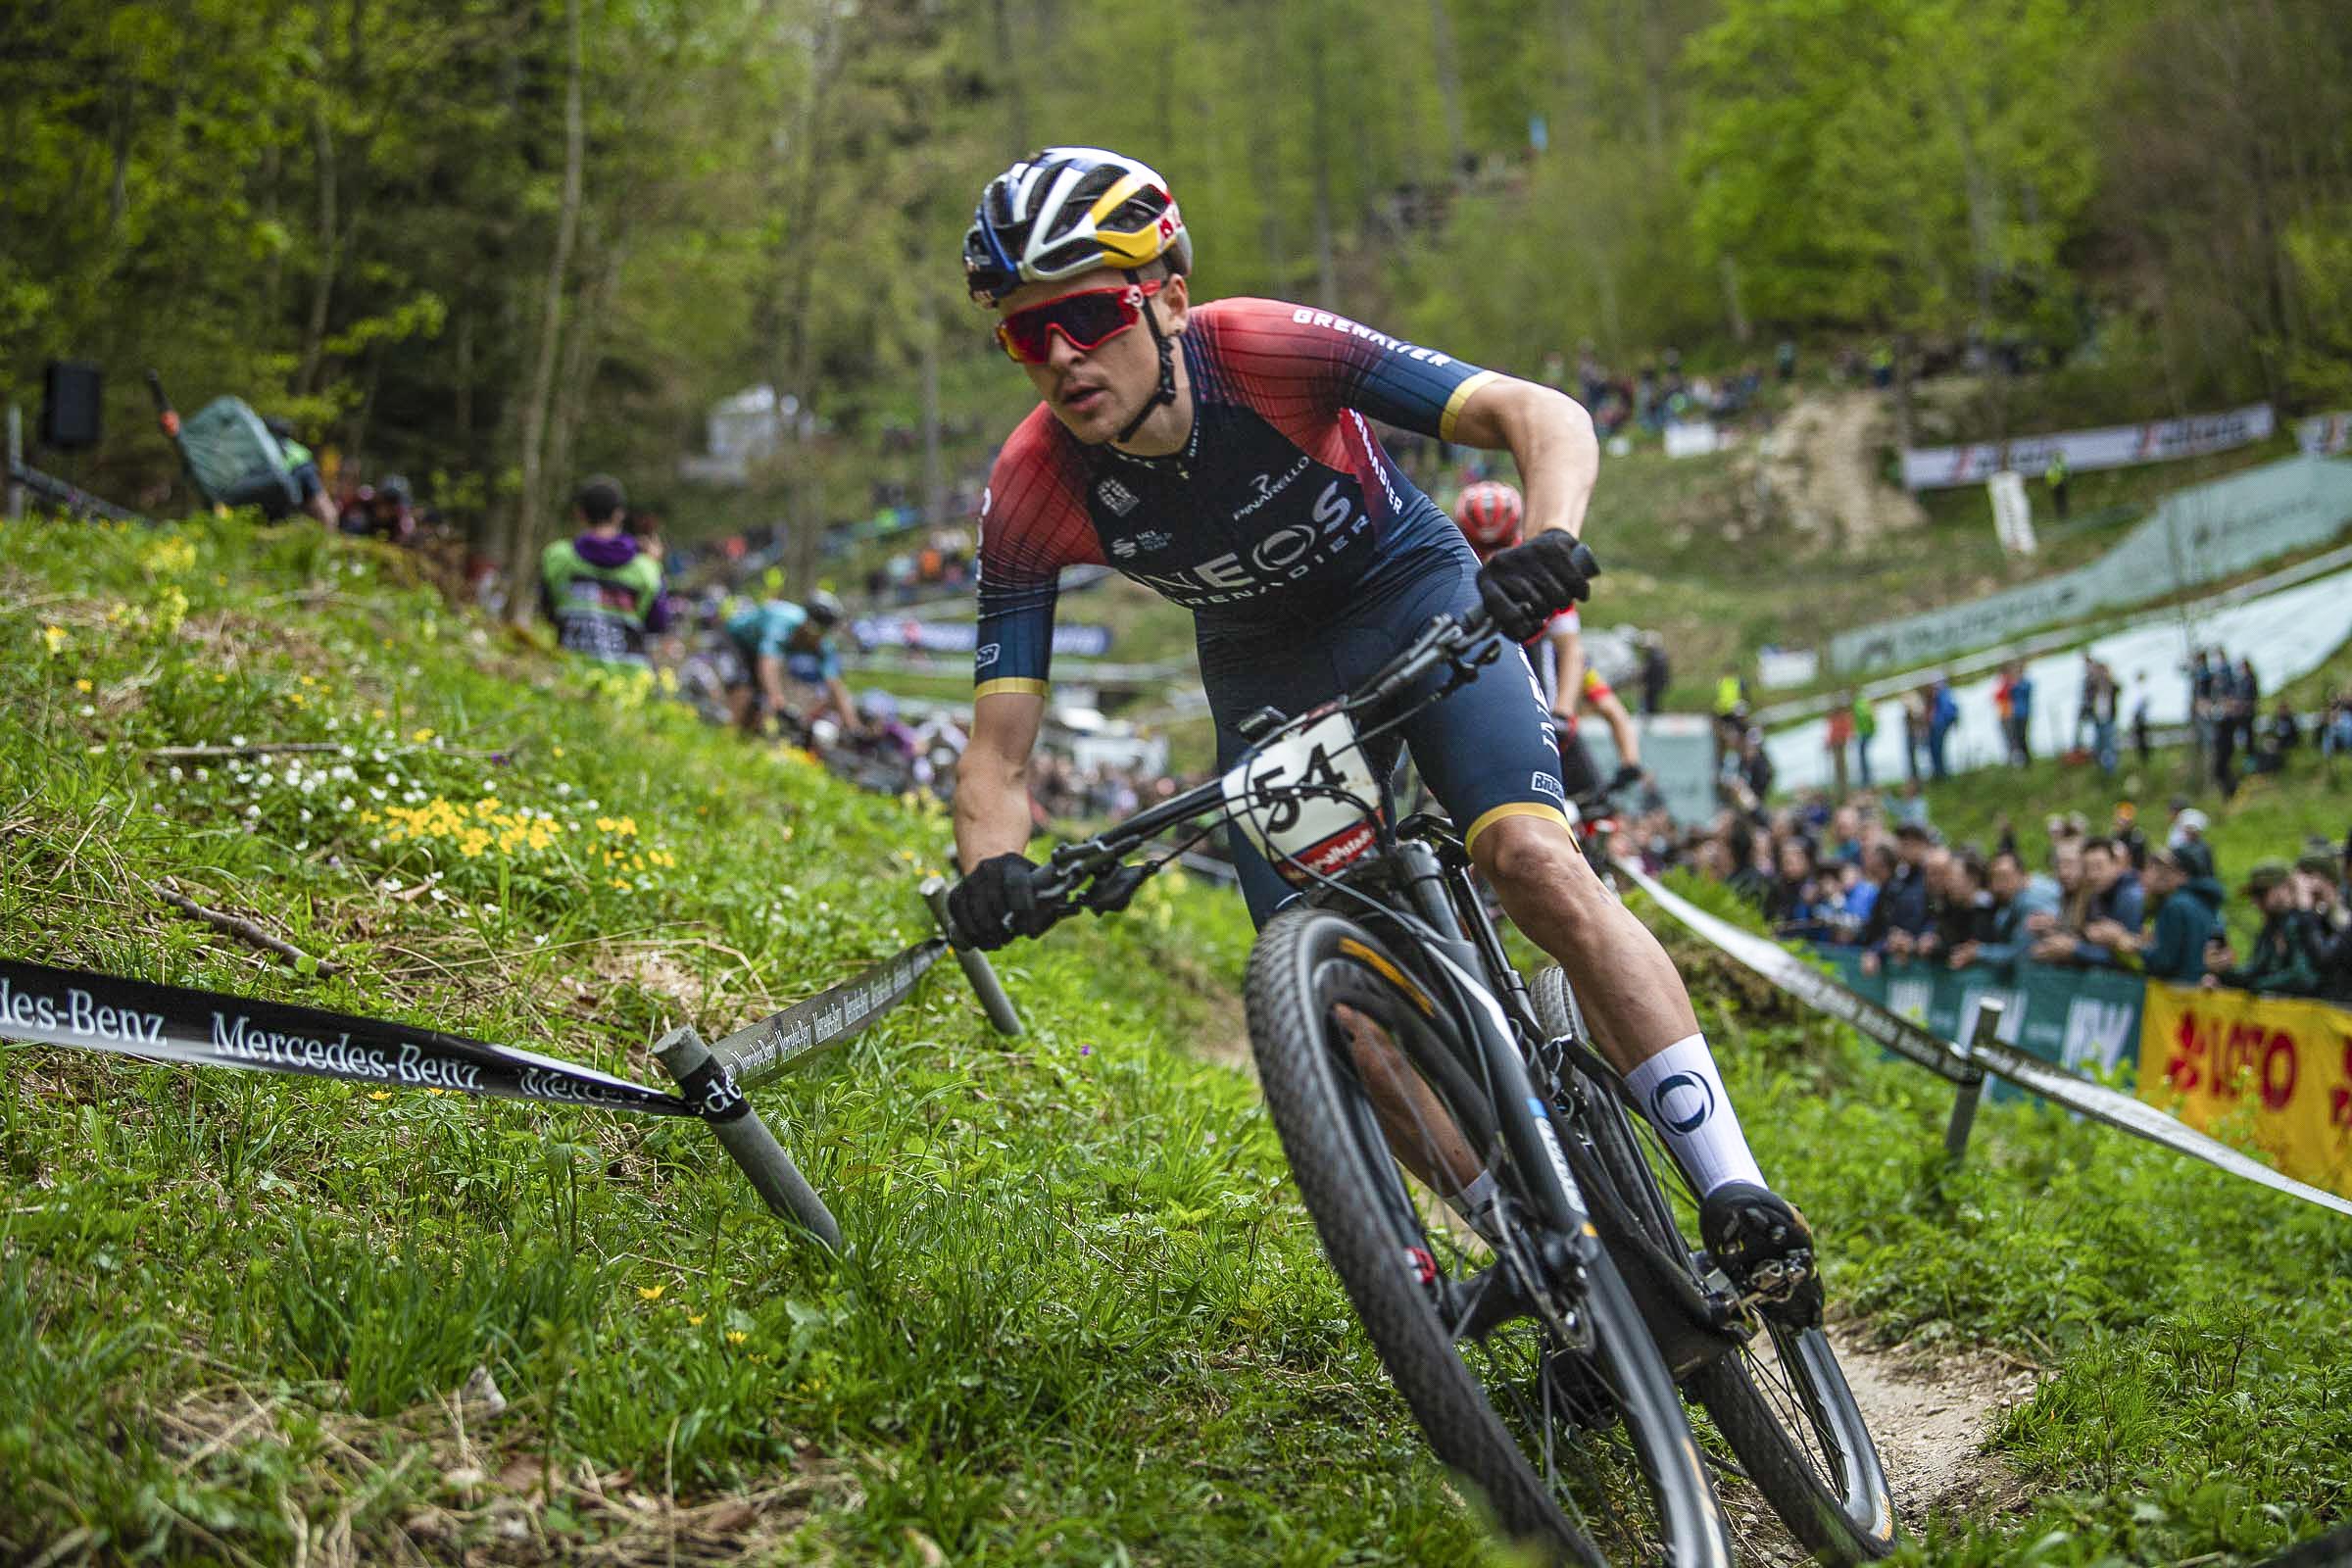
[1630,785,2352,1004]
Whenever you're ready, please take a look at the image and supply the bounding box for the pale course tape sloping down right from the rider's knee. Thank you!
[1616,860,2352,1215]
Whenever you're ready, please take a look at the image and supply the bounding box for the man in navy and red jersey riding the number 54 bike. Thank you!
[951,148,1821,1321]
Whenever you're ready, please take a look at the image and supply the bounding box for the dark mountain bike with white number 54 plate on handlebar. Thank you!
[936,592,1893,1568]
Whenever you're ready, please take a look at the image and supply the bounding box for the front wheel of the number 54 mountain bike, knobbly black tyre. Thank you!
[1247,907,1731,1568]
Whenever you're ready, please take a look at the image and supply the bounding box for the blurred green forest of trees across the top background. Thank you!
[0,0,2352,597]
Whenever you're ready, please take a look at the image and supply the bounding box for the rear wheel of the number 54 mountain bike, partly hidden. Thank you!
[1534,968,1895,1563]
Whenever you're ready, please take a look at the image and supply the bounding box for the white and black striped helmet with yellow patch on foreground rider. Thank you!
[964,148,1193,308]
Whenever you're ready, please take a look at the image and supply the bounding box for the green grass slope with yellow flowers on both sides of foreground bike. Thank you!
[0,522,2352,1568]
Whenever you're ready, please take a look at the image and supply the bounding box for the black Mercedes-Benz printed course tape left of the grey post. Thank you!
[0,959,704,1116]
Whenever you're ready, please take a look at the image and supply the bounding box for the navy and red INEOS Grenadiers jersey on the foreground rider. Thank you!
[974,299,1494,696]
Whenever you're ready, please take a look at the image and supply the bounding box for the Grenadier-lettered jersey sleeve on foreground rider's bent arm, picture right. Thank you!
[1195,299,1495,442]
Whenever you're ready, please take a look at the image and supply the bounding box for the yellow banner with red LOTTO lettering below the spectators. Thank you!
[2140,983,2352,1197]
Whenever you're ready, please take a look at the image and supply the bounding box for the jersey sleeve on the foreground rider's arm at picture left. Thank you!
[971,407,1103,698]
